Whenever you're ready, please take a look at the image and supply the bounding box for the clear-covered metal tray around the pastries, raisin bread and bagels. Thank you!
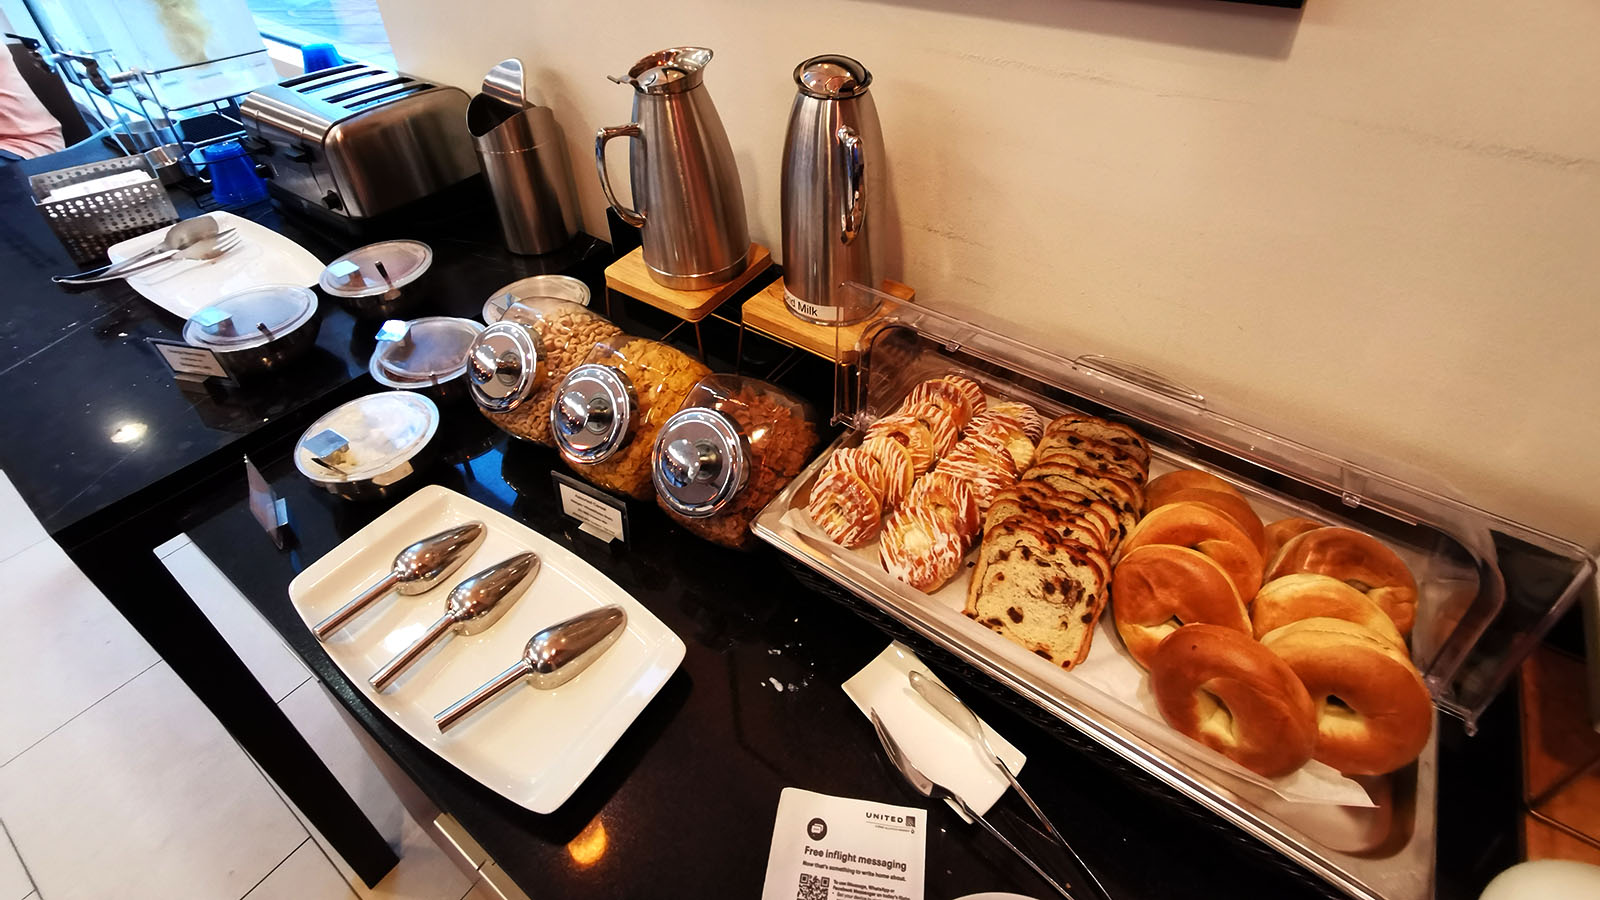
[754,303,1595,900]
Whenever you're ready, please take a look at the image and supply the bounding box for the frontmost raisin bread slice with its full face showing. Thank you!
[963,531,1106,668]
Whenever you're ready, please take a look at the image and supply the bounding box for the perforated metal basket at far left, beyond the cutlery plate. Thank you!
[27,155,178,266]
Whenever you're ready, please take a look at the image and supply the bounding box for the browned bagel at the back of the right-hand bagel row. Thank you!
[1266,527,1416,634]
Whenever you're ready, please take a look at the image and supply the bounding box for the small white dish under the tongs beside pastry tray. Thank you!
[843,641,1027,818]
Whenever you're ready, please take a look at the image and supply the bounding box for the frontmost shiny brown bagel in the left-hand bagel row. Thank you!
[1150,625,1317,778]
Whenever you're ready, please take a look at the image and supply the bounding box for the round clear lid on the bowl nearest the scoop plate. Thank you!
[294,391,438,482]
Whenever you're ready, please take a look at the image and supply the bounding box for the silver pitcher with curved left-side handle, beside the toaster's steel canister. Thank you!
[595,46,750,290]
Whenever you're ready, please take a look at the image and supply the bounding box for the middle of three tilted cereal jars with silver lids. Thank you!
[549,335,710,500]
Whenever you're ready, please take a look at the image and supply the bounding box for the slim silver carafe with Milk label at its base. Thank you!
[782,56,885,325]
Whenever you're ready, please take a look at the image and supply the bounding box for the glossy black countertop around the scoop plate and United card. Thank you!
[184,419,1515,898]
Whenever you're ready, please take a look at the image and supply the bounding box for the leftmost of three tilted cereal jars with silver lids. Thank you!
[467,298,622,447]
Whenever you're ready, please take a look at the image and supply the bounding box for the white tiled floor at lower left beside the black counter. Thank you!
[0,474,494,900]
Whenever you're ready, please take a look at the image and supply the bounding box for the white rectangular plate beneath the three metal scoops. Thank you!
[290,485,683,814]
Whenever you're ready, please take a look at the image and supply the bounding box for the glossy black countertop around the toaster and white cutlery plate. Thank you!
[0,143,610,546]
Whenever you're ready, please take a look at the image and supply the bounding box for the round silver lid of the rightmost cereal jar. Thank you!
[650,407,750,519]
